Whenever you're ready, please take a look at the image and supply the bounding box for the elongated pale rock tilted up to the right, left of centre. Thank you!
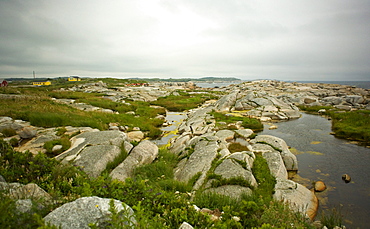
[110,140,158,181]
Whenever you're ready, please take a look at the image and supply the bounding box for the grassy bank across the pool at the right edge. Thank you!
[300,106,370,145]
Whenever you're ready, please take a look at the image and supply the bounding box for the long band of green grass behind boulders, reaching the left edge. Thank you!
[0,92,163,138]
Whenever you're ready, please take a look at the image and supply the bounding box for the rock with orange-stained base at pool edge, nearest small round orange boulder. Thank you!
[273,178,319,220]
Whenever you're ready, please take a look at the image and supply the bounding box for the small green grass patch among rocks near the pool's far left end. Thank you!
[211,111,263,132]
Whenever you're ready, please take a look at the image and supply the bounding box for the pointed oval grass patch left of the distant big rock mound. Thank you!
[151,91,217,111]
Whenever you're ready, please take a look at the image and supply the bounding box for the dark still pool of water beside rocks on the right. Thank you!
[258,113,370,228]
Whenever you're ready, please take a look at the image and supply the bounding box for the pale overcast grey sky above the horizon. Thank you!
[0,0,370,80]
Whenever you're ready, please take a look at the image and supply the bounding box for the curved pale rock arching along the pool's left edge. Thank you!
[251,135,298,171]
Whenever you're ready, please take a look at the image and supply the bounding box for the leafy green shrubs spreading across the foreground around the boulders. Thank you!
[0,140,312,228]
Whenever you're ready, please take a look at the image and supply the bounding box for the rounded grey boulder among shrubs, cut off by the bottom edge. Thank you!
[44,196,136,229]
